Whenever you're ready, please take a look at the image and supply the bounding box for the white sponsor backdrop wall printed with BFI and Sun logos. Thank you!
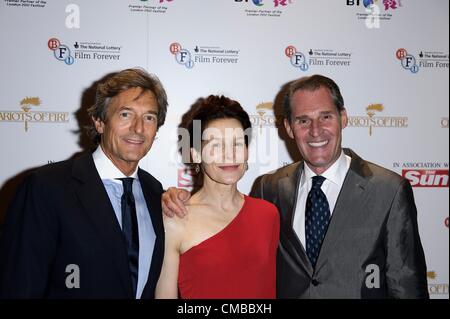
[0,0,449,298]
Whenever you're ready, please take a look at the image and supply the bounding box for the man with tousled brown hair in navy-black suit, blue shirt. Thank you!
[0,69,167,299]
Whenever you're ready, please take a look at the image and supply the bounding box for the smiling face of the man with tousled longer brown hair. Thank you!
[94,88,158,176]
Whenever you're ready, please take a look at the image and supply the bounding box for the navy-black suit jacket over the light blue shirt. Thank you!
[0,154,164,299]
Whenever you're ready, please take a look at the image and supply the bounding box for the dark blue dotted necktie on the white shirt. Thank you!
[305,176,330,267]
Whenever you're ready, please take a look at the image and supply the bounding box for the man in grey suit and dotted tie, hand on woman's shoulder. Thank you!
[163,75,428,298]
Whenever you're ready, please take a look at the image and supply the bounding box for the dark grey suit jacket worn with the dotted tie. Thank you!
[252,149,428,298]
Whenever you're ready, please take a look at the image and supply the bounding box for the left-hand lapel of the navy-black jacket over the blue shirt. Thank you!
[72,154,135,298]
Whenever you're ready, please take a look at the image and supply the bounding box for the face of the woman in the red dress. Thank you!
[191,118,248,185]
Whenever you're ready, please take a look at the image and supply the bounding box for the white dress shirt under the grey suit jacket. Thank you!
[293,151,352,247]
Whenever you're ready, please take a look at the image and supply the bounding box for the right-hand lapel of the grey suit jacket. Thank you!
[316,149,372,271]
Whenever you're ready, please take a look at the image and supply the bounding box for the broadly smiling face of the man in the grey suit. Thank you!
[284,87,347,175]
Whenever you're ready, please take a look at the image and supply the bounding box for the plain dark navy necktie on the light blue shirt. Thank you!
[119,177,139,295]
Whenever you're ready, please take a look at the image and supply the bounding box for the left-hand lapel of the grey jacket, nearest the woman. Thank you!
[278,163,313,274]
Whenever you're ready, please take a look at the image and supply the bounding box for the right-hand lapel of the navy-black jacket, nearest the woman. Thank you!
[138,169,164,298]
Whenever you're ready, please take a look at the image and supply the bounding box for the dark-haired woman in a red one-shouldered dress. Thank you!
[156,96,279,299]
